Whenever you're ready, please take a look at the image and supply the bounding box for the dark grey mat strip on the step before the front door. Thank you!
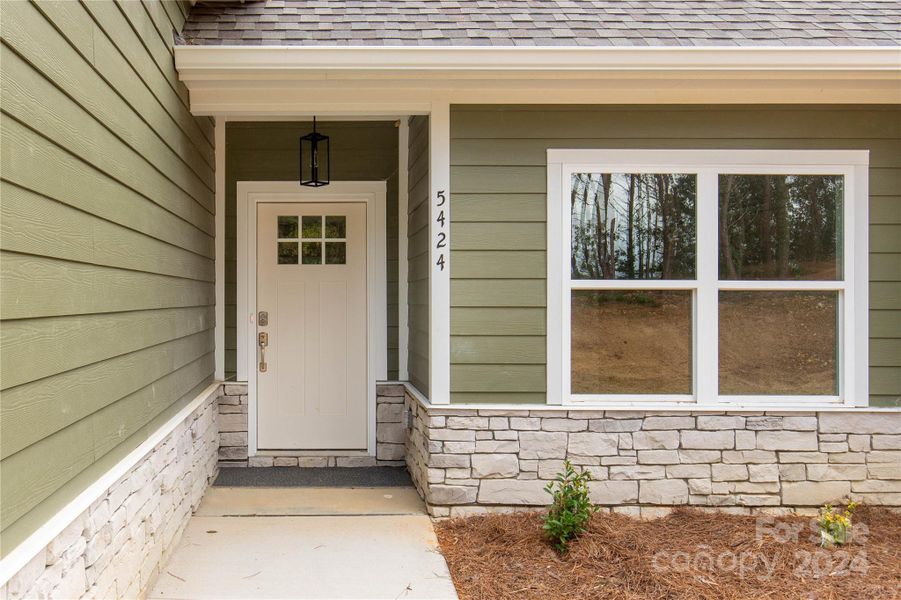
[213,467,413,488]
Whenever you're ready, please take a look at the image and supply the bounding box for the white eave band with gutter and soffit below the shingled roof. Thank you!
[175,46,901,114]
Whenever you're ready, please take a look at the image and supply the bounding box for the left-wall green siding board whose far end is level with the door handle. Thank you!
[0,329,213,458]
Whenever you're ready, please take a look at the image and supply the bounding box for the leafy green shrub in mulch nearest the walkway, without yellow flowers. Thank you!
[543,460,598,554]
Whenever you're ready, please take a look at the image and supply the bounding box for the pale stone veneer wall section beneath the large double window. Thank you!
[405,394,901,516]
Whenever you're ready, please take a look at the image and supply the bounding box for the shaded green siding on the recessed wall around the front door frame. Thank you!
[225,121,398,379]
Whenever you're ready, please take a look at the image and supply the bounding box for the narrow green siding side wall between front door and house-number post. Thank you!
[407,117,430,396]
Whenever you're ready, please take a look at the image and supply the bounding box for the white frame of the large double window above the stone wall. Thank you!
[547,149,869,410]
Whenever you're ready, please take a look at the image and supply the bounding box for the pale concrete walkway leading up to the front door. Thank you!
[148,487,457,600]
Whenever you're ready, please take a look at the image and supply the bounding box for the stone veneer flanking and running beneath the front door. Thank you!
[219,383,405,467]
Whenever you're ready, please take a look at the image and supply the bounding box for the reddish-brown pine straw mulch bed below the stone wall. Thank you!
[436,507,901,600]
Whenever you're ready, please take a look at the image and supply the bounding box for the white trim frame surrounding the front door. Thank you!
[235,181,388,456]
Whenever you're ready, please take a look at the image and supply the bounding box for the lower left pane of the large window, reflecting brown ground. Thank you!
[571,290,692,394]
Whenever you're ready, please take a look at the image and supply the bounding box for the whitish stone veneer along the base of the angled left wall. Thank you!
[0,387,221,600]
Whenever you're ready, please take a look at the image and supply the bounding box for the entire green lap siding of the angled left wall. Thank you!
[0,1,215,556]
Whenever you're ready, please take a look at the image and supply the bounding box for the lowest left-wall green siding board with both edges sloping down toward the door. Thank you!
[0,182,215,282]
